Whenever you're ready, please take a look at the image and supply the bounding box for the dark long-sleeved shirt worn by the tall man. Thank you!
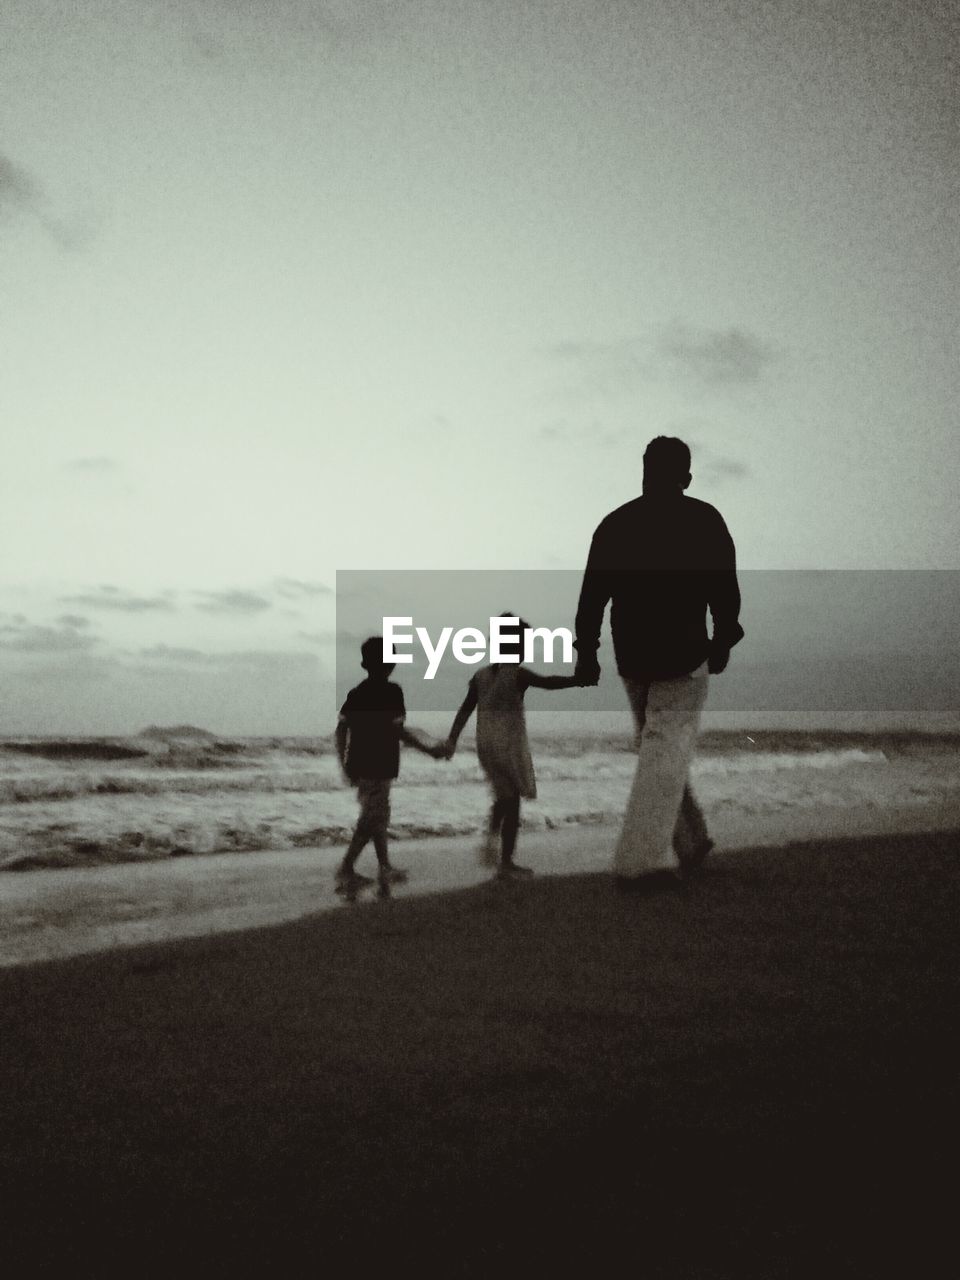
[576,493,744,680]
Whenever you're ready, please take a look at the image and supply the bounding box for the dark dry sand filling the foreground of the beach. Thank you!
[0,835,960,1277]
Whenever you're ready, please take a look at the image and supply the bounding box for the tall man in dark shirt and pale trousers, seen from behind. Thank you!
[576,435,744,888]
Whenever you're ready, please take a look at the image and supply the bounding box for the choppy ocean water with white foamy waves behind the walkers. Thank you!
[0,727,960,870]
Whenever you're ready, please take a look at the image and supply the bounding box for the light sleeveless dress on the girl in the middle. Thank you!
[472,663,536,800]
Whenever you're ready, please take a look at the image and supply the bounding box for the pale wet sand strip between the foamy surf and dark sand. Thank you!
[0,805,960,968]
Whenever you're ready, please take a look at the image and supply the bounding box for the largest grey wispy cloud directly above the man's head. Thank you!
[547,324,778,396]
